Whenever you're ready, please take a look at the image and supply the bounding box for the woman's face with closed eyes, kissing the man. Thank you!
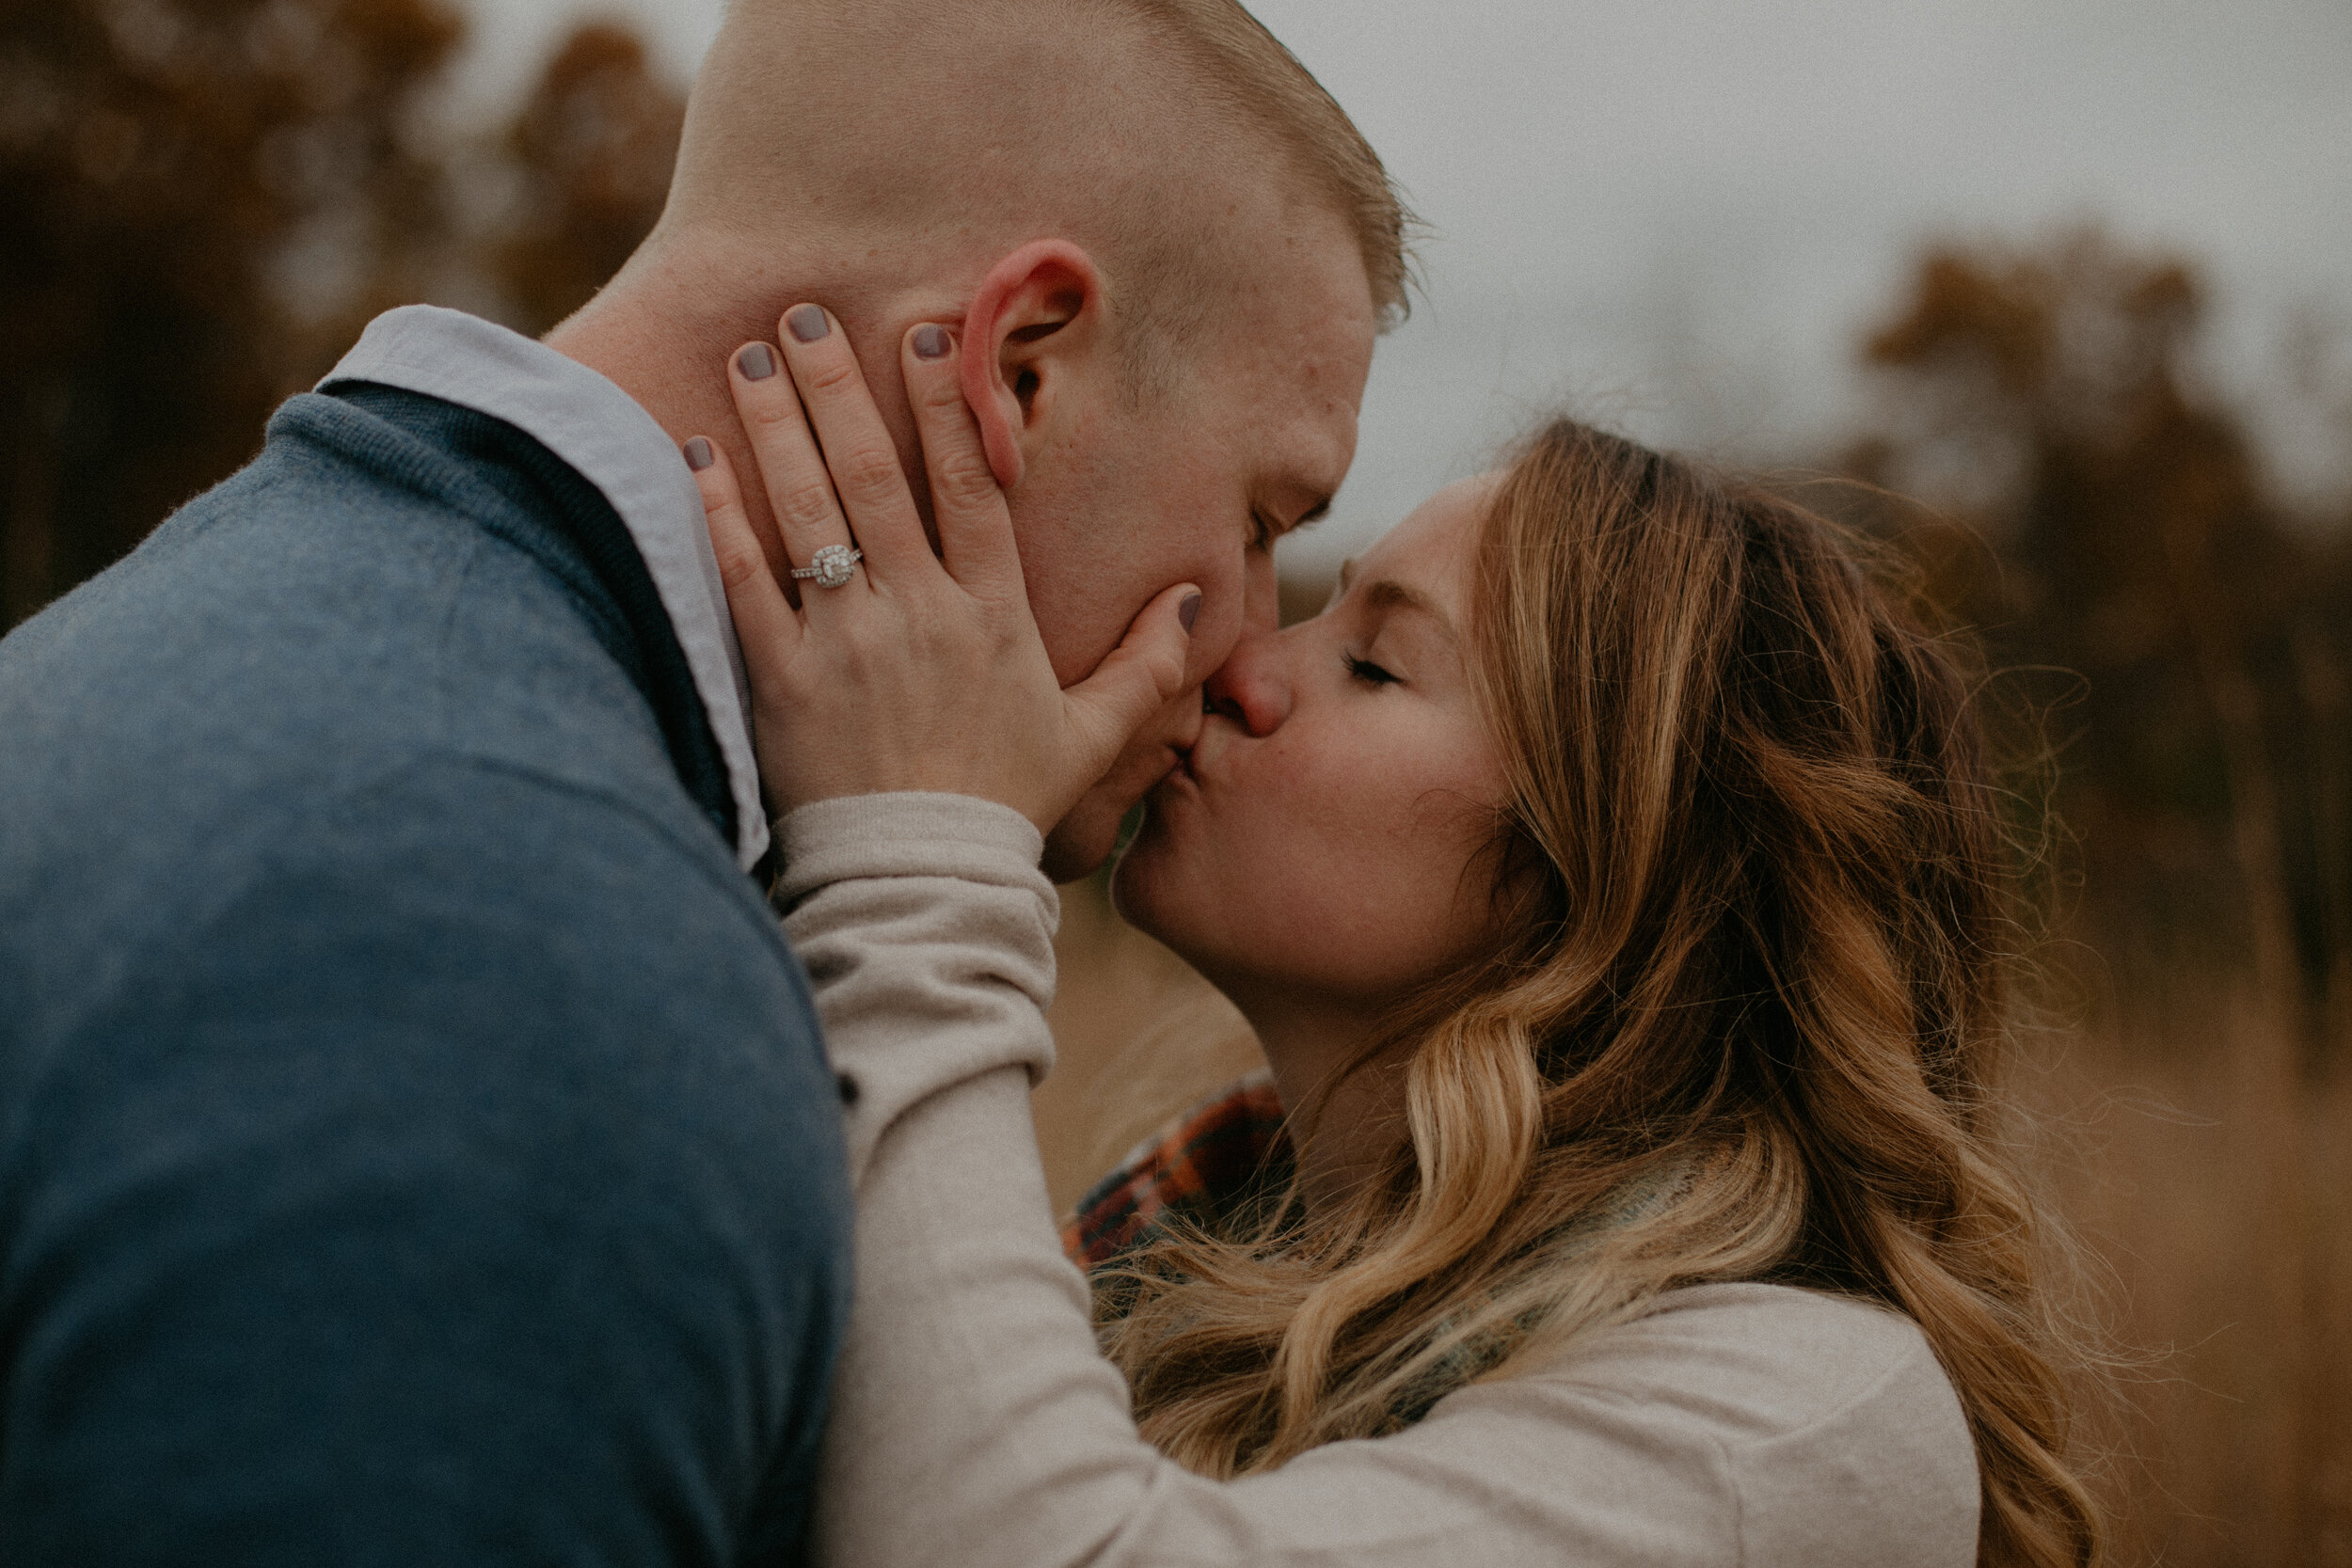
[1113,477,1503,1011]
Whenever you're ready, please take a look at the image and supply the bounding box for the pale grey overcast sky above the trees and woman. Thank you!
[444,0,2352,564]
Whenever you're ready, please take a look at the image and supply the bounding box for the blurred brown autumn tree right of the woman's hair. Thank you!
[1853,232,2352,1039]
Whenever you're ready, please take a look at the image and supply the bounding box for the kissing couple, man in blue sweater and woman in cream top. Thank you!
[0,0,2101,1568]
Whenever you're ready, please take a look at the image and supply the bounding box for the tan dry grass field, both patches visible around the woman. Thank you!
[1035,884,2352,1568]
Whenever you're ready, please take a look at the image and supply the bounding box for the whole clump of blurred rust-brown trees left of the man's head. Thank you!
[0,0,685,630]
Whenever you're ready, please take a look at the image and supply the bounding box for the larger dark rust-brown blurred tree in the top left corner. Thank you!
[0,0,461,626]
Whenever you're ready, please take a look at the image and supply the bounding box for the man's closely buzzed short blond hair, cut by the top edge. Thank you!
[652,0,1414,388]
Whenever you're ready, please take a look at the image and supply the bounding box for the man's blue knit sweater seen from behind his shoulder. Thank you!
[0,386,850,1568]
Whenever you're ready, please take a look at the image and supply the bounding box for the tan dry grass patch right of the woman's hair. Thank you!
[2018,966,2352,1568]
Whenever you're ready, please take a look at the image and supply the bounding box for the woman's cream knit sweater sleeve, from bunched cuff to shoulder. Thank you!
[784,795,1976,1568]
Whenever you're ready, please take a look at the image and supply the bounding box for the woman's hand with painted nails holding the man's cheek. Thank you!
[687,306,1200,832]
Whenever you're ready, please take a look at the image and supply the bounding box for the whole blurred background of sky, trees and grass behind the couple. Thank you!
[0,0,2352,1568]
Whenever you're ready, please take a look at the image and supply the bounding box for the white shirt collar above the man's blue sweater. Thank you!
[318,306,767,870]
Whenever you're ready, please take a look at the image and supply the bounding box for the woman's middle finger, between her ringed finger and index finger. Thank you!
[776,306,936,580]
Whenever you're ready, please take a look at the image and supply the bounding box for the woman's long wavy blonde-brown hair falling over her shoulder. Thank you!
[1101,420,2101,1566]
